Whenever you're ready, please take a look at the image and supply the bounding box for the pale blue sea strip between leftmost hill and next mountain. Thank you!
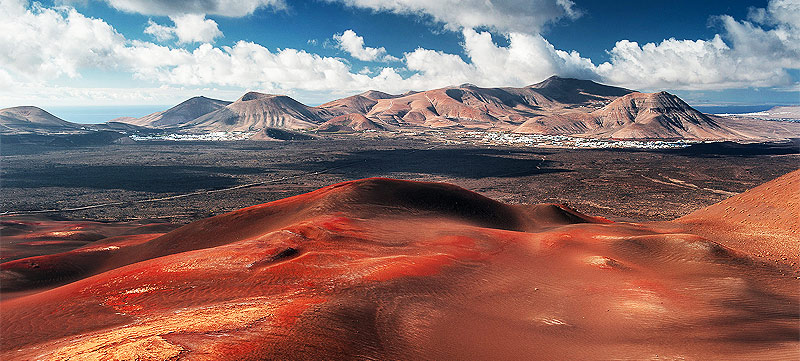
[42,105,172,124]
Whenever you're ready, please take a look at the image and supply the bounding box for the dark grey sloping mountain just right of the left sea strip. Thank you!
[121,96,231,128]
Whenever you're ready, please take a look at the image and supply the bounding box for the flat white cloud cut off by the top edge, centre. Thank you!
[328,0,580,34]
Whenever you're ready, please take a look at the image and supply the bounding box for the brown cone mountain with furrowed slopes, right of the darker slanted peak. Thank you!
[184,92,324,131]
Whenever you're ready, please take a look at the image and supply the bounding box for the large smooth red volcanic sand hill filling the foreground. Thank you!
[0,179,800,360]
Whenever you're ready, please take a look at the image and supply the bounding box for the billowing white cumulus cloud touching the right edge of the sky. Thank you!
[597,0,800,89]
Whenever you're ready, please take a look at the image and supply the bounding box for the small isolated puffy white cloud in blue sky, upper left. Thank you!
[144,14,222,44]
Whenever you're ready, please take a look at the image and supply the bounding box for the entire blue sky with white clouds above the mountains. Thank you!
[0,0,800,116]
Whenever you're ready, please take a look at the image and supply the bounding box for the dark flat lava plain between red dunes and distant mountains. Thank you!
[0,138,800,223]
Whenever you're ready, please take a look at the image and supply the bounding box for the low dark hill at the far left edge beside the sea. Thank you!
[0,106,84,134]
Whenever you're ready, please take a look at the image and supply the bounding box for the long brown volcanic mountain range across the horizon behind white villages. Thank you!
[0,76,800,140]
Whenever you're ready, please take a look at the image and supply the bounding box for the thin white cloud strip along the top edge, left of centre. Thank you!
[105,0,286,17]
